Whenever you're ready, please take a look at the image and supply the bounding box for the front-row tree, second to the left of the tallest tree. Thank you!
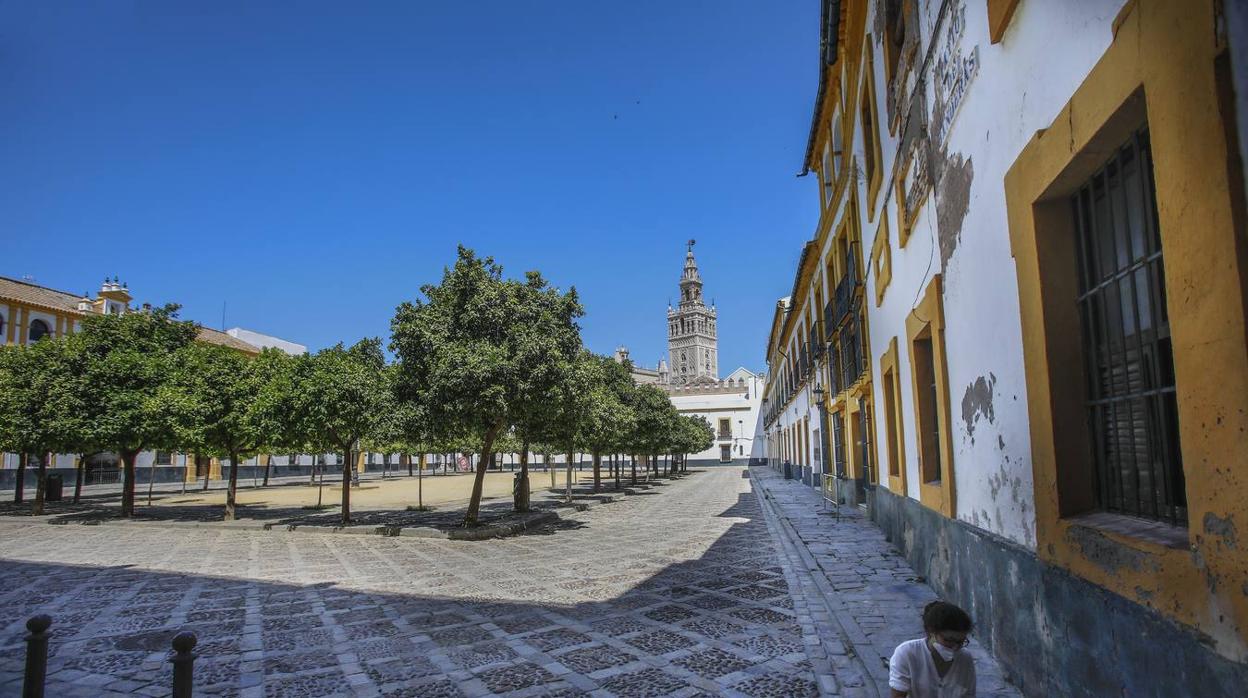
[161,342,293,521]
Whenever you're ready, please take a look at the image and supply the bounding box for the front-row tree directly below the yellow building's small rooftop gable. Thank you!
[67,305,198,517]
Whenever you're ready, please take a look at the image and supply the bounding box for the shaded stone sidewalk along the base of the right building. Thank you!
[751,468,1021,697]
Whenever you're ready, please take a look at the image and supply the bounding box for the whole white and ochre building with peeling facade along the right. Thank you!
[764,0,1248,696]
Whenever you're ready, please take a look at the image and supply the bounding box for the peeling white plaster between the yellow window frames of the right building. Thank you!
[855,0,1123,549]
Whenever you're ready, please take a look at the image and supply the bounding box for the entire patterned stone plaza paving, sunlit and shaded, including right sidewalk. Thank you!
[0,467,1017,698]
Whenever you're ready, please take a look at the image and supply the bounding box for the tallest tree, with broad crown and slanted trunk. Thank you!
[391,247,583,526]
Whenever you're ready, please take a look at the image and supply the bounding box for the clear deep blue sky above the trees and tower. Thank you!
[0,0,819,373]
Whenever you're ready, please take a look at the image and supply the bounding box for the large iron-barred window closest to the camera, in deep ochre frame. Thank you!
[1071,126,1187,526]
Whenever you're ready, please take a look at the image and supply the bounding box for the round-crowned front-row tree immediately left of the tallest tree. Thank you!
[291,338,394,526]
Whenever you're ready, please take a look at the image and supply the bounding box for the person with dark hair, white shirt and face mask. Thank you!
[889,601,975,698]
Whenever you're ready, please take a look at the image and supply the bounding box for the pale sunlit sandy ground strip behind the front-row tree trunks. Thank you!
[152,469,591,511]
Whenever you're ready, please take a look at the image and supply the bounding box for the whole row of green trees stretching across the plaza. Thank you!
[0,247,713,526]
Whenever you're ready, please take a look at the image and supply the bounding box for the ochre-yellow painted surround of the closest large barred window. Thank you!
[1006,0,1248,662]
